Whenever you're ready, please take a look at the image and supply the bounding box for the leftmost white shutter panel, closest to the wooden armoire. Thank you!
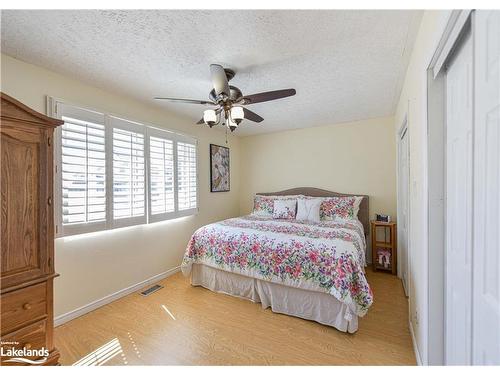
[57,105,107,234]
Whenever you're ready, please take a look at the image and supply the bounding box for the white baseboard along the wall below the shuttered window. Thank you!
[54,266,181,327]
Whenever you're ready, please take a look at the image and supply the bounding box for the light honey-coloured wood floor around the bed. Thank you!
[55,270,415,365]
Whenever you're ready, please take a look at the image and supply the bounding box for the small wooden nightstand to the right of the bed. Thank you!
[370,220,397,275]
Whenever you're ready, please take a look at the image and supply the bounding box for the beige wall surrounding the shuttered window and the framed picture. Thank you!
[1,55,240,316]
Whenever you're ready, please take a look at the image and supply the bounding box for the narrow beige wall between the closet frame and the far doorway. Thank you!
[395,11,450,364]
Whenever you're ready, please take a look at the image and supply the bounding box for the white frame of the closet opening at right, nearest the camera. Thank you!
[427,10,473,365]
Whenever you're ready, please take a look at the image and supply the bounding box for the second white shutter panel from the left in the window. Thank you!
[108,117,146,228]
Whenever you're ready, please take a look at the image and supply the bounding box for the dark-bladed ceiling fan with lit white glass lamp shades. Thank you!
[155,64,296,131]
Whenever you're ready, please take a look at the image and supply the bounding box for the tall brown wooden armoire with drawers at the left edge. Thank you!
[0,93,62,365]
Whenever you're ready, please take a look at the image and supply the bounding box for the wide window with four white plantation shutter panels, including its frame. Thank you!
[49,99,198,237]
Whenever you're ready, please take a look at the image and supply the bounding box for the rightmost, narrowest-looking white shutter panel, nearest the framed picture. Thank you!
[177,141,197,211]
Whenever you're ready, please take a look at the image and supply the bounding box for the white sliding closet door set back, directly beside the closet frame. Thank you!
[446,32,473,365]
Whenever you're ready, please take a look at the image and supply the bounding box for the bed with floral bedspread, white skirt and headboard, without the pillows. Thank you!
[181,188,373,333]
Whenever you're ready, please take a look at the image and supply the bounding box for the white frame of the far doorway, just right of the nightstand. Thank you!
[396,113,411,303]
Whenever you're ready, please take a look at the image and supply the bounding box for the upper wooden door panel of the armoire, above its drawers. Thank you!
[0,120,52,289]
